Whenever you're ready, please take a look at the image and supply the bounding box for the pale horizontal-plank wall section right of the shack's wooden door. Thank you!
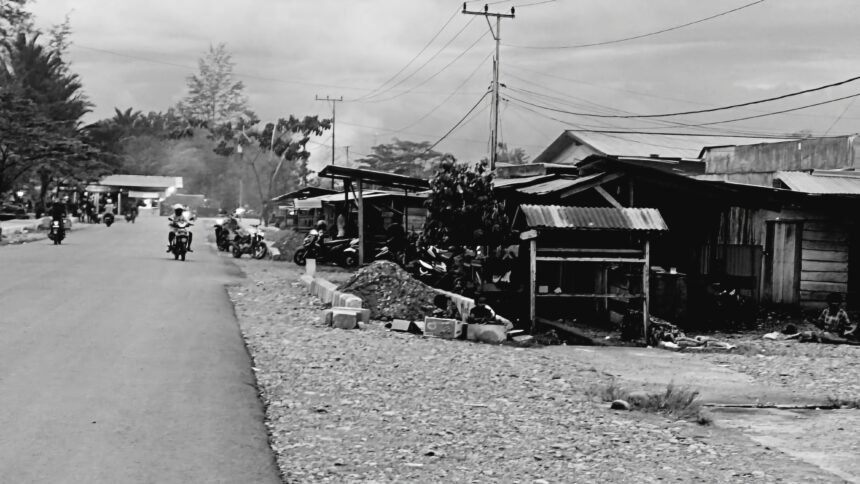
[800,221,848,307]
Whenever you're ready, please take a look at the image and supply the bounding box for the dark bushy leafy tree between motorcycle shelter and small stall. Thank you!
[424,156,510,247]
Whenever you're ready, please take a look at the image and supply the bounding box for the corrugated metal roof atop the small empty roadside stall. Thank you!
[520,205,669,231]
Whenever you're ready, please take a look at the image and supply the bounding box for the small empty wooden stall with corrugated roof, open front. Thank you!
[514,205,668,334]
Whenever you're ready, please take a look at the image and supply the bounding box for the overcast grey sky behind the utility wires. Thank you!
[33,0,860,171]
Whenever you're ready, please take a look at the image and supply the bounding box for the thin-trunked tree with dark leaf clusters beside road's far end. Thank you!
[212,115,331,221]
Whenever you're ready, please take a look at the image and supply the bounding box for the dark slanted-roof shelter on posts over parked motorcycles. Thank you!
[318,165,430,264]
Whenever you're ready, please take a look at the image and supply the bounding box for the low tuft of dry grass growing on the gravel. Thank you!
[586,379,713,425]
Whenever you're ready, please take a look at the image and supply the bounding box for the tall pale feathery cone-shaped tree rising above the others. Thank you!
[178,43,249,128]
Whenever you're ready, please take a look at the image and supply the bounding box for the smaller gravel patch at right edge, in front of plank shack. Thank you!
[701,334,860,402]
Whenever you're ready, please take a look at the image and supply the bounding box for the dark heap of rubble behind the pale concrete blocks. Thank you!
[338,261,437,321]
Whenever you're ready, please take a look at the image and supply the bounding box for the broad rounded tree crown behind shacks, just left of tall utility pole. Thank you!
[358,138,442,178]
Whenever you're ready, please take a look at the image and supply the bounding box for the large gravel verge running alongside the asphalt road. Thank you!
[229,259,842,483]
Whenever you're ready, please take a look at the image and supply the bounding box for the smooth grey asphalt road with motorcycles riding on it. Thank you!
[0,216,280,484]
